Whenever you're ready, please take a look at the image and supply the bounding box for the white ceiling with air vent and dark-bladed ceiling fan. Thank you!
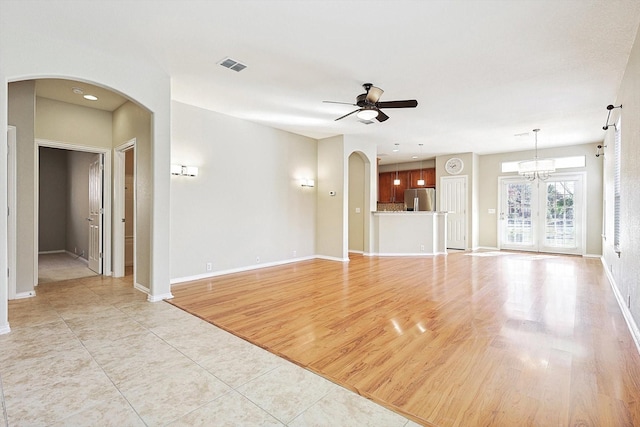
[2,0,640,164]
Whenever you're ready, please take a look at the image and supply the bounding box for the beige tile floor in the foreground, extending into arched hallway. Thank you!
[0,276,417,427]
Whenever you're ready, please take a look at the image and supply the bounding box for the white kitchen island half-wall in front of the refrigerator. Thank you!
[372,211,447,256]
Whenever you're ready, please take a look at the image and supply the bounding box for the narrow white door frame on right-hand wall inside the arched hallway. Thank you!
[113,138,137,283]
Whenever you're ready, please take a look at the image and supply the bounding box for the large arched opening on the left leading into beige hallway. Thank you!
[8,78,153,298]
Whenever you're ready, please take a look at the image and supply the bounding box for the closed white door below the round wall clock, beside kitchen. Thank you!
[439,176,467,249]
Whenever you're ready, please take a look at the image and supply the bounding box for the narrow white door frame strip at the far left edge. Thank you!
[7,126,18,300]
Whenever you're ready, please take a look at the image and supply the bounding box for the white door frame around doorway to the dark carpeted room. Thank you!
[33,138,112,285]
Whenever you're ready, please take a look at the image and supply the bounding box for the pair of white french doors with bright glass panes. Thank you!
[498,173,586,254]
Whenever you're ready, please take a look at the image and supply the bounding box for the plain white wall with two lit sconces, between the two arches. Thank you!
[171,101,320,283]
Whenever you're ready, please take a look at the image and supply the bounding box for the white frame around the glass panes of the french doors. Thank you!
[496,171,587,256]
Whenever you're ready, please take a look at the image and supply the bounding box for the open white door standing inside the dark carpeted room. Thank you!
[87,154,102,274]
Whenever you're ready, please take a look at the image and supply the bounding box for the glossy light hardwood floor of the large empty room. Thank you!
[171,252,640,427]
